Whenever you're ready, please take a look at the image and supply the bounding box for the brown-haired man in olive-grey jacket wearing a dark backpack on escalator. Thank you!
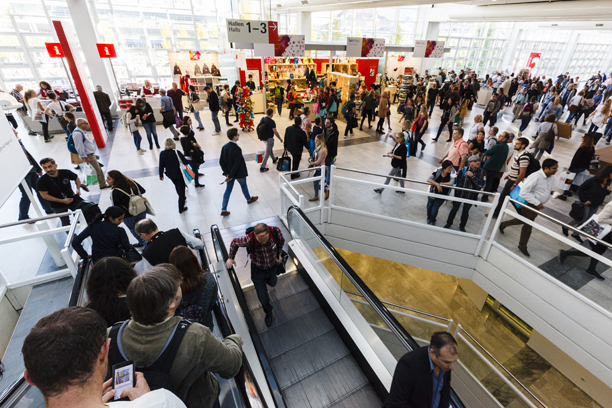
[106,265,242,408]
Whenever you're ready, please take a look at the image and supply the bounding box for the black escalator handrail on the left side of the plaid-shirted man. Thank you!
[210,224,286,408]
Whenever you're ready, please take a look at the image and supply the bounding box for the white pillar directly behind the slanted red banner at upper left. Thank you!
[66,0,119,116]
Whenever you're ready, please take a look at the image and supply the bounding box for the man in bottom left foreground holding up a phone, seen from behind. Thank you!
[21,306,185,408]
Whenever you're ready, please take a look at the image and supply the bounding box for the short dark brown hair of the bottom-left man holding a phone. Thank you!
[21,306,107,399]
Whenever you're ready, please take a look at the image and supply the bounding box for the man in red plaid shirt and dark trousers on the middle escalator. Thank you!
[225,223,285,327]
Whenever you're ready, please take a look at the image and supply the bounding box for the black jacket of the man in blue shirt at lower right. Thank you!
[383,347,451,408]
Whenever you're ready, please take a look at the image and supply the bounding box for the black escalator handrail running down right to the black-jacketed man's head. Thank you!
[287,205,464,408]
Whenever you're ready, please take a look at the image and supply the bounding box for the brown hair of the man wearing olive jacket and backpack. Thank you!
[125,264,181,326]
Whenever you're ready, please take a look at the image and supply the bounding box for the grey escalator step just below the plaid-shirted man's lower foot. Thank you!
[260,308,334,359]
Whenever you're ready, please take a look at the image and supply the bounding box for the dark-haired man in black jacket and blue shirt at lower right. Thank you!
[383,332,459,408]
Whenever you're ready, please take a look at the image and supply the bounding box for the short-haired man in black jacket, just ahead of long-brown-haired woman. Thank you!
[136,218,204,271]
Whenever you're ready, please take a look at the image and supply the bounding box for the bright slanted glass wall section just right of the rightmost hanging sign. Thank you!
[432,22,514,76]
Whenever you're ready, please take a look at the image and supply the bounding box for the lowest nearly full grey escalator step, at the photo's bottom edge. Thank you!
[283,355,371,408]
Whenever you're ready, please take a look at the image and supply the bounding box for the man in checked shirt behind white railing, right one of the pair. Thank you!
[444,155,486,232]
